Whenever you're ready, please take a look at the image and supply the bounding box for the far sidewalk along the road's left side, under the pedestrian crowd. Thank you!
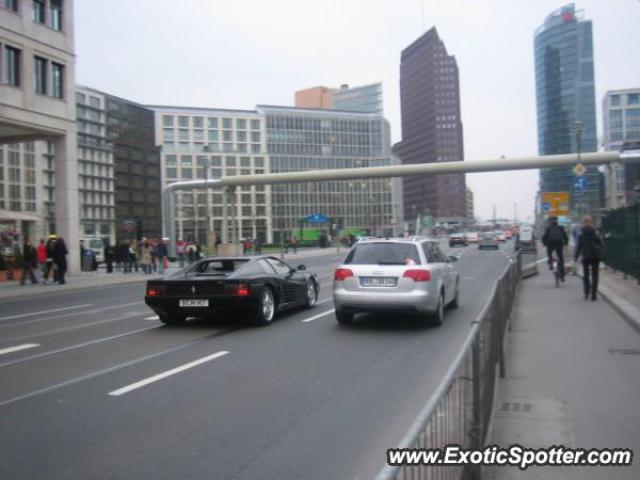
[0,247,340,299]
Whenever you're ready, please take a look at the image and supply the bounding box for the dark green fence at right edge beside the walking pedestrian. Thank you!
[602,204,640,282]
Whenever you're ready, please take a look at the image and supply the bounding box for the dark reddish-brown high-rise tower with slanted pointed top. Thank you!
[393,27,467,224]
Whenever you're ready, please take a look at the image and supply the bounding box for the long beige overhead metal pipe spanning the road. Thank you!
[163,152,640,255]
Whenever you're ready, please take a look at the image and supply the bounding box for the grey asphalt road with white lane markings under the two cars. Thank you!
[0,244,510,480]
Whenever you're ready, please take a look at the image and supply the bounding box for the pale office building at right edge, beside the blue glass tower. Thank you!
[602,88,640,208]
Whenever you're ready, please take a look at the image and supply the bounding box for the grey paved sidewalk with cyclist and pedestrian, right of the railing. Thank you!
[485,264,640,480]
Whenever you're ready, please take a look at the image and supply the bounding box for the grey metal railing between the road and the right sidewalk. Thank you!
[376,254,521,480]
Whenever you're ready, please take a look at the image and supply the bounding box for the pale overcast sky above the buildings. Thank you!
[75,0,640,220]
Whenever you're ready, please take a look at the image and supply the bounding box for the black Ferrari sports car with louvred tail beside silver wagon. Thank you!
[144,256,320,325]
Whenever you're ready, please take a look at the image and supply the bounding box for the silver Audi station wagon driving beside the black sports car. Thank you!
[333,237,460,325]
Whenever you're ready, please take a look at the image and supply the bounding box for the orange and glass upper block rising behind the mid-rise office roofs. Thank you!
[295,83,383,115]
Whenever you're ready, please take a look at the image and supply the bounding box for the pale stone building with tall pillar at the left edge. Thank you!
[0,0,79,271]
